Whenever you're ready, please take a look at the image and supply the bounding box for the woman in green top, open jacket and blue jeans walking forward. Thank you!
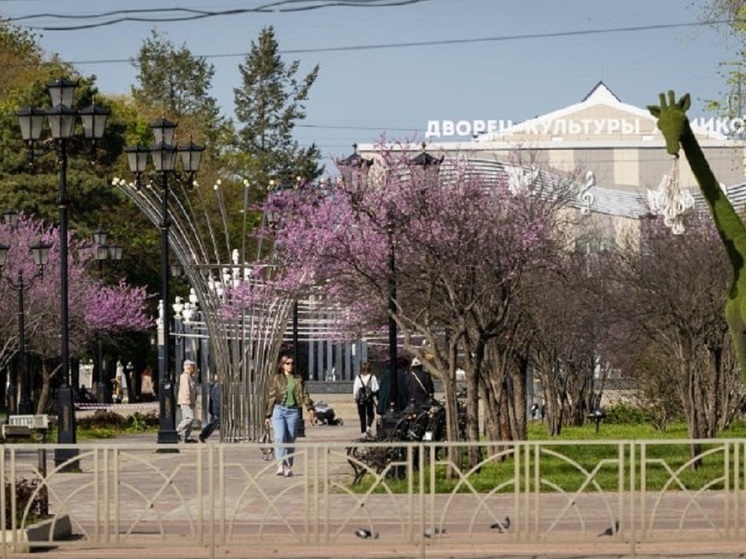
[265,355,314,477]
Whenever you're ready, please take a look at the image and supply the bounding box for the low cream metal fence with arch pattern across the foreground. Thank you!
[0,440,746,557]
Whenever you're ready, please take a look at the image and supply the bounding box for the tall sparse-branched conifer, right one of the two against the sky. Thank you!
[234,27,323,185]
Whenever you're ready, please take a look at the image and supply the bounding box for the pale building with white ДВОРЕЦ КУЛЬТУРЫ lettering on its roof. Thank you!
[359,82,746,234]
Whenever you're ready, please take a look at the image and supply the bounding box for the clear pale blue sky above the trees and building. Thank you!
[0,0,741,171]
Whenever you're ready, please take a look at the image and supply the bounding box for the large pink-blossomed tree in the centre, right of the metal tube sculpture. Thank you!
[256,143,569,460]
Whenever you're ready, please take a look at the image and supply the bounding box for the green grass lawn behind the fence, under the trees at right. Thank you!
[361,422,746,493]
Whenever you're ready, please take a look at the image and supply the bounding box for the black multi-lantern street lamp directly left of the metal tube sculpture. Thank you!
[125,118,205,444]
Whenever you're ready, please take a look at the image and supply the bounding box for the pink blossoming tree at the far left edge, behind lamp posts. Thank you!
[0,215,152,410]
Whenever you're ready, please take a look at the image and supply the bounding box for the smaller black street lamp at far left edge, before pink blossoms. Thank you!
[0,235,51,415]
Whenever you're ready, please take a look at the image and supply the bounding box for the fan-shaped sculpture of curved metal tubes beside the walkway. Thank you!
[113,179,292,442]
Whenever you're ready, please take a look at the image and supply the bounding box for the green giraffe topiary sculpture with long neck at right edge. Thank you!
[648,91,746,384]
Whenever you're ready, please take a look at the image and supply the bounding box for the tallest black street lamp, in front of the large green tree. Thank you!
[16,78,109,466]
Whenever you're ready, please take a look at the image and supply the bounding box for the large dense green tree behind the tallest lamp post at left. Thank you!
[0,18,124,236]
